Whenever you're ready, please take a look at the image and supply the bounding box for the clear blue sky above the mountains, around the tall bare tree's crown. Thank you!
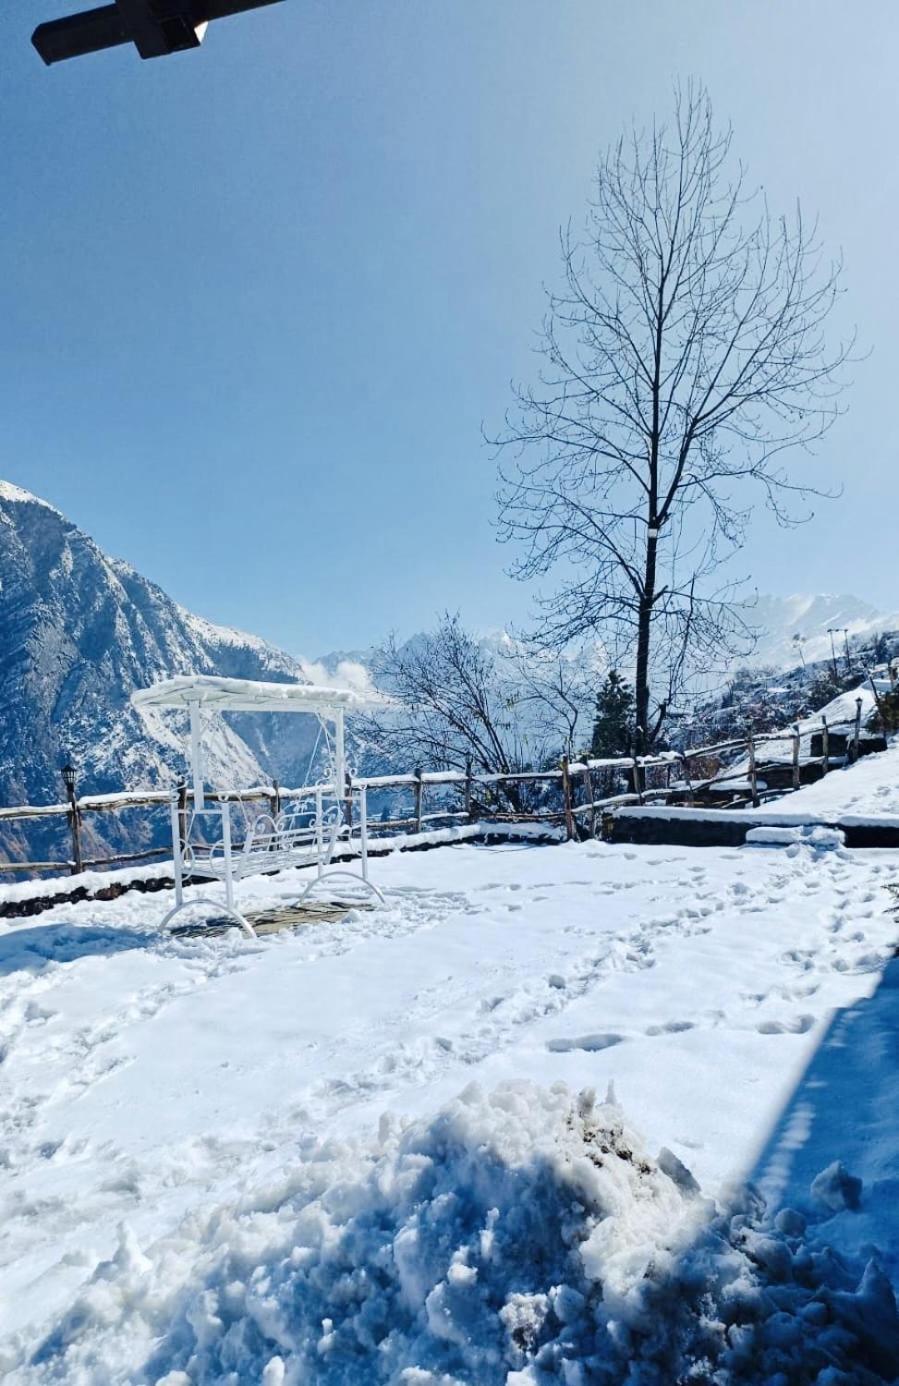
[0,0,899,656]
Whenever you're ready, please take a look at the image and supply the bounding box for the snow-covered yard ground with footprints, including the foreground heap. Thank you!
[0,826,899,1386]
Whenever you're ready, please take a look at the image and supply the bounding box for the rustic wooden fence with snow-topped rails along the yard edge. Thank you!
[0,699,862,875]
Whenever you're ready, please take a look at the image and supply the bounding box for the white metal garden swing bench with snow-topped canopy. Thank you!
[132,674,384,937]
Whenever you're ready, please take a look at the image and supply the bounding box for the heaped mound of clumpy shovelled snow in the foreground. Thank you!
[8,1082,899,1386]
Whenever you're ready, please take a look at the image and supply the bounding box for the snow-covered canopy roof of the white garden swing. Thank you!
[132,674,391,717]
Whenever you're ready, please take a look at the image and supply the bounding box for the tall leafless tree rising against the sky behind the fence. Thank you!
[495,86,849,751]
